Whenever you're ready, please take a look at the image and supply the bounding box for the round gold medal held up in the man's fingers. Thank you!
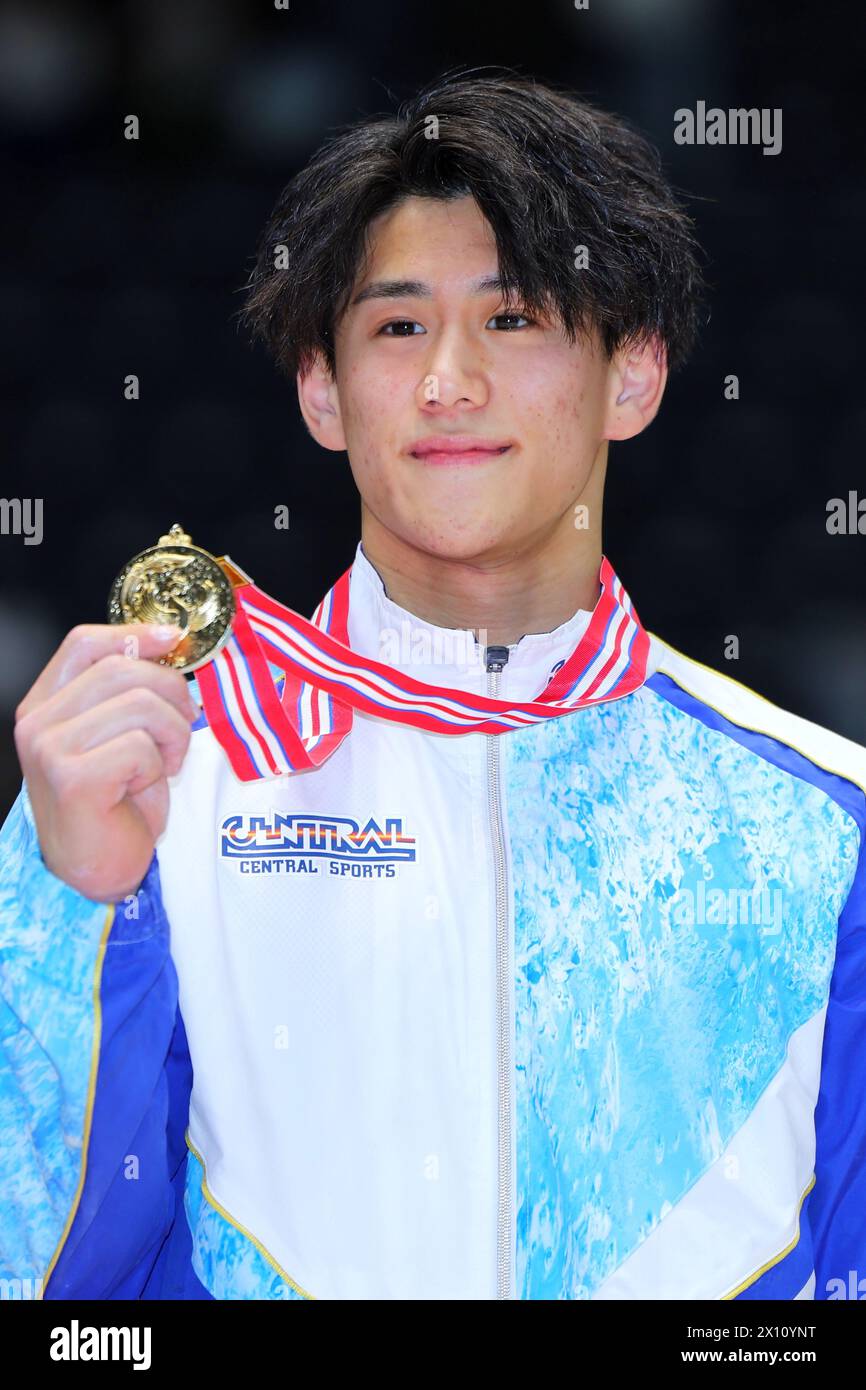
[108,523,252,671]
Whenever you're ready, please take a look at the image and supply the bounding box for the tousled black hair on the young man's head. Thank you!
[239,68,703,379]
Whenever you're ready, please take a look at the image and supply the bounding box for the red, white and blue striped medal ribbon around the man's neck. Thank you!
[196,556,649,781]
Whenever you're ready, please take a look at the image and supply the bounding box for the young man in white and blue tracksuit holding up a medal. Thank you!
[0,75,866,1300]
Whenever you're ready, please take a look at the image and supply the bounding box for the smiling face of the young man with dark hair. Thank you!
[311,197,622,563]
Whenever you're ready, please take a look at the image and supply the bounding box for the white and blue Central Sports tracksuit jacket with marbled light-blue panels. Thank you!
[0,542,866,1300]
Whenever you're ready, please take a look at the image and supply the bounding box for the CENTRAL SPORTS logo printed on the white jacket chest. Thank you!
[220,810,416,878]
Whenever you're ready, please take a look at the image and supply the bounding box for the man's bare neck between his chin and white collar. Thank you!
[361,506,602,646]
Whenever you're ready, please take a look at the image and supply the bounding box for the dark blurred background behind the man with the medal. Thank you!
[0,0,866,816]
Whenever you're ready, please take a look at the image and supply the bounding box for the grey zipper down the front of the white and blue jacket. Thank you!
[484,646,514,1298]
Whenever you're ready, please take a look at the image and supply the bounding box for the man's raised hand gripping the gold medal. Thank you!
[15,623,199,904]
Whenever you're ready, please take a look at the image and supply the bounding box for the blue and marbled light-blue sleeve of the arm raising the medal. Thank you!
[0,784,192,1298]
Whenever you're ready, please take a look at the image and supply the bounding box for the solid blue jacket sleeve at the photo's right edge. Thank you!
[809,817,866,1298]
